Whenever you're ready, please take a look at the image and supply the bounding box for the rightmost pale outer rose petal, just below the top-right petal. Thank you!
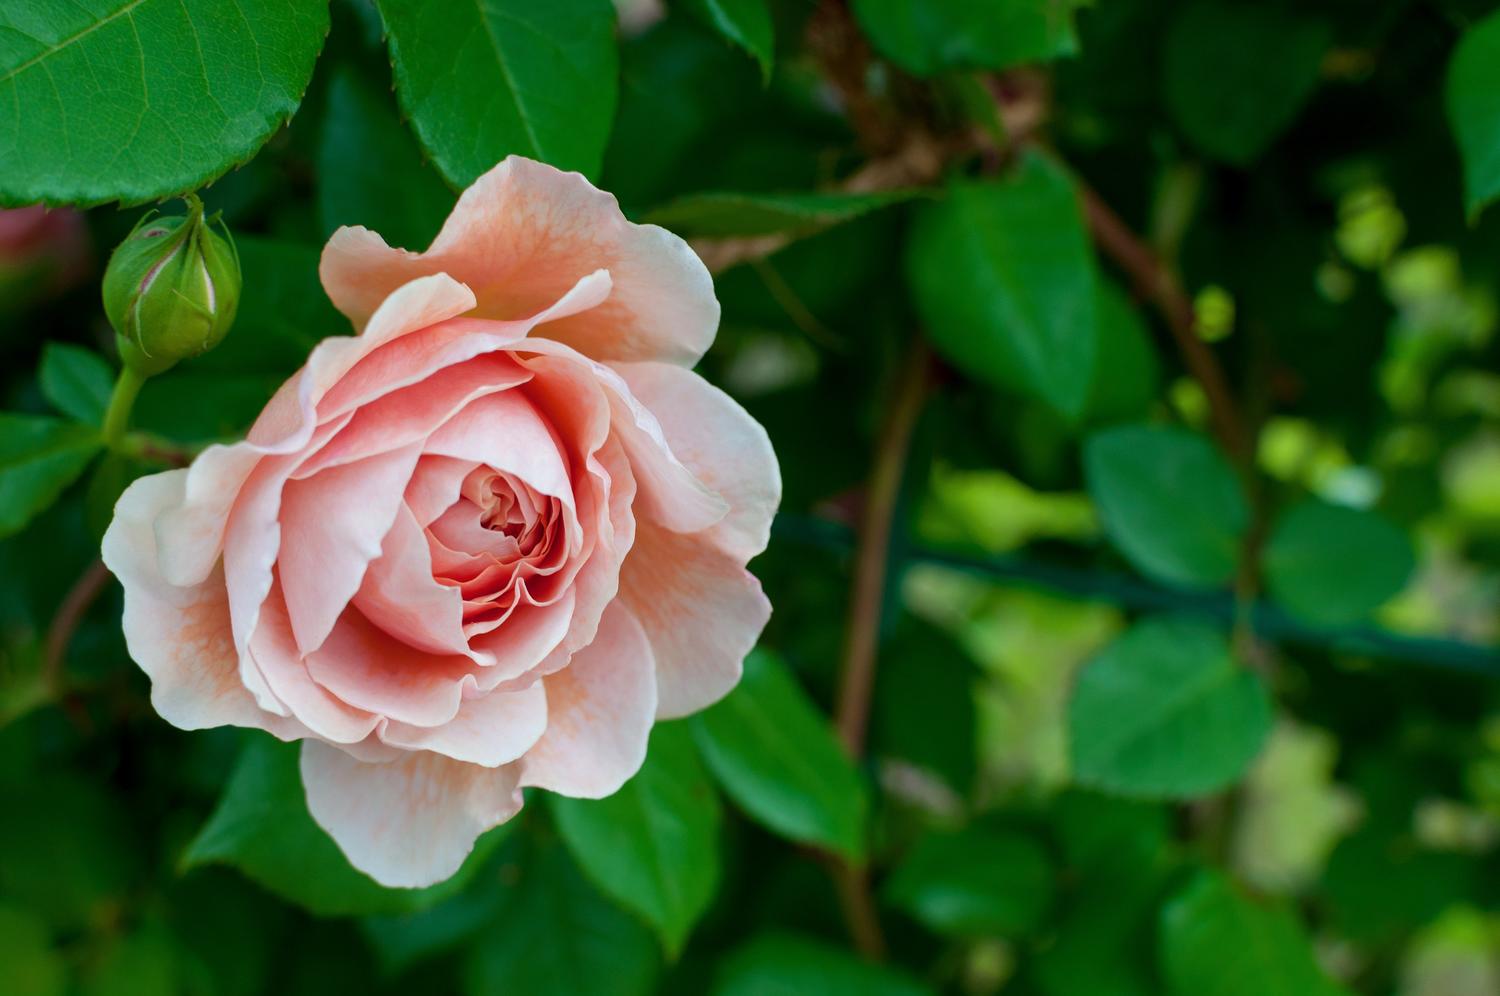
[615,363,782,560]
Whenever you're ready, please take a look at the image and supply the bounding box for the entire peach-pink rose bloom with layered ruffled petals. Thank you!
[104,158,782,887]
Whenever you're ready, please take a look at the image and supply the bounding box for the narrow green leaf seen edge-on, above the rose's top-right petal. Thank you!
[642,191,921,239]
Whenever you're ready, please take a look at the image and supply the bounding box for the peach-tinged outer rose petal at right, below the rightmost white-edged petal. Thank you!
[620,521,771,719]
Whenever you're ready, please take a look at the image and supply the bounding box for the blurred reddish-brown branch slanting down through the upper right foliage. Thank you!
[1079,180,1251,464]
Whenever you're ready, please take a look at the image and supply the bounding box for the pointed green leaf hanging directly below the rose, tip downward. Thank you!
[551,723,723,954]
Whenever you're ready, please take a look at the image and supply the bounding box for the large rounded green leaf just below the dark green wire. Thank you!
[1068,620,1272,798]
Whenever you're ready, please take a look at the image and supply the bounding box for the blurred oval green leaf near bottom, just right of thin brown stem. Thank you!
[885,827,1052,938]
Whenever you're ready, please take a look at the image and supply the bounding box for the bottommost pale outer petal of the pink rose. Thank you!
[302,740,521,888]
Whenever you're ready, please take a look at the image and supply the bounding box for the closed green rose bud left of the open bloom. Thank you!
[104,195,240,377]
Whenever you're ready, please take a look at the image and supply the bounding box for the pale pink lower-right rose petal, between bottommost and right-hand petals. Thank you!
[521,602,657,800]
